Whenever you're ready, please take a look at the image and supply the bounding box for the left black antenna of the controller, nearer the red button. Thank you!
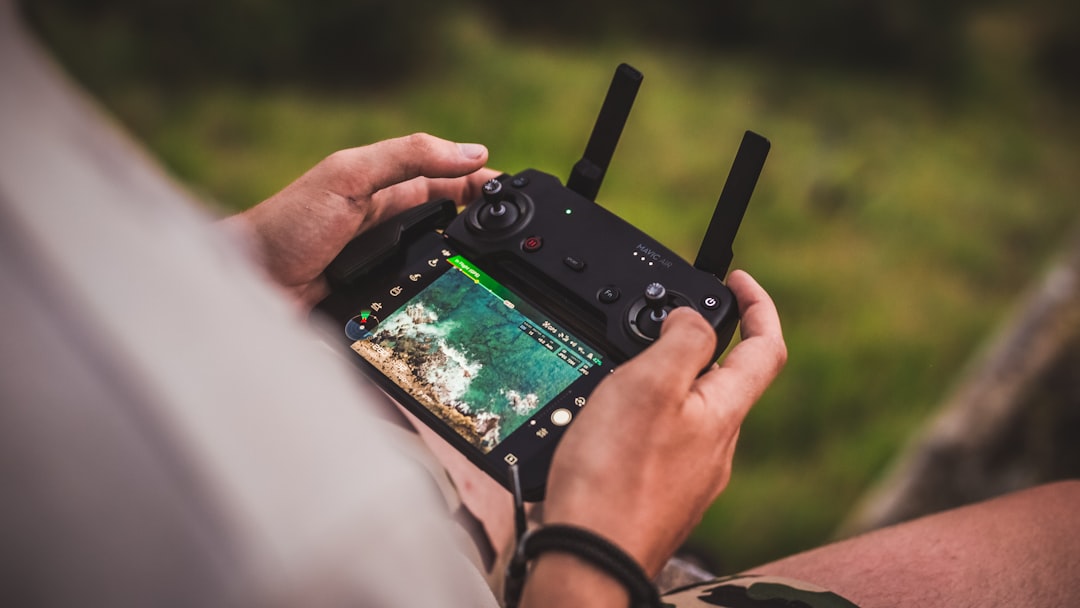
[566,64,645,201]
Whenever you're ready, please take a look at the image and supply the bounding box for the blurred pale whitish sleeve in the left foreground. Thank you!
[0,5,496,607]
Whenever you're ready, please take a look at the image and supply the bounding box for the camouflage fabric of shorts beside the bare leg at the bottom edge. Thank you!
[661,575,859,608]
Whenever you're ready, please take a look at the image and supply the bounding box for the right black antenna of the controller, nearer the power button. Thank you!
[693,131,771,279]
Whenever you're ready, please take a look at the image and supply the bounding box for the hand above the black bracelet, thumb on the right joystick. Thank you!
[541,271,787,576]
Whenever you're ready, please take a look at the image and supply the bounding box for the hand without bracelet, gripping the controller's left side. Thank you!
[226,133,498,306]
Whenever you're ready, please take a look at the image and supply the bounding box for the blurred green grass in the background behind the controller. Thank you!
[39,8,1080,571]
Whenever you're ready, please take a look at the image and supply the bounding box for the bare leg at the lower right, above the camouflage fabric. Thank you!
[751,479,1080,608]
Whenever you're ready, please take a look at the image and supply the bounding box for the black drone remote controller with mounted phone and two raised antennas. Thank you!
[316,64,769,500]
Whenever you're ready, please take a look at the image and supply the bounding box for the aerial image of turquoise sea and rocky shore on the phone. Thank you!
[352,269,588,452]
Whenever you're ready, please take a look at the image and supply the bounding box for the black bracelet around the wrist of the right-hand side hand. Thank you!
[518,525,660,608]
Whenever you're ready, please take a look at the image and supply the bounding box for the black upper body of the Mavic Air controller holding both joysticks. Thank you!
[445,170,739,362]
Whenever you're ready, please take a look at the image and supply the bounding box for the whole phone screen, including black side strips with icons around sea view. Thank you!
[346,252,609,453]
